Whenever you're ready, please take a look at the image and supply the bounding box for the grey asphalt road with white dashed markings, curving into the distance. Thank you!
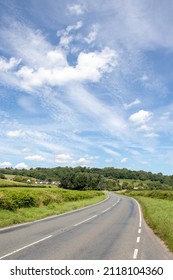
[0,193,173,260]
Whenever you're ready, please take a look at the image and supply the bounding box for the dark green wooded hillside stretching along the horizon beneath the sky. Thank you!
[0,166,173,190]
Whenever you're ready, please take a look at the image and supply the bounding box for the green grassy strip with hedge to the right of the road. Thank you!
[125,190,173,252]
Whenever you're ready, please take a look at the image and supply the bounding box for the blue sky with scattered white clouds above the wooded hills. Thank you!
[0,0,173,175]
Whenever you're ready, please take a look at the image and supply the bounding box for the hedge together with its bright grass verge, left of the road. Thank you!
[0,187,106,227]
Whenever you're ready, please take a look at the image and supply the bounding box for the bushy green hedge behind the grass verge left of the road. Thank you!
[0,188,102,211]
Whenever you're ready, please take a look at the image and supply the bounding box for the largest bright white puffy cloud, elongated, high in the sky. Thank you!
[16,47,118,89]
